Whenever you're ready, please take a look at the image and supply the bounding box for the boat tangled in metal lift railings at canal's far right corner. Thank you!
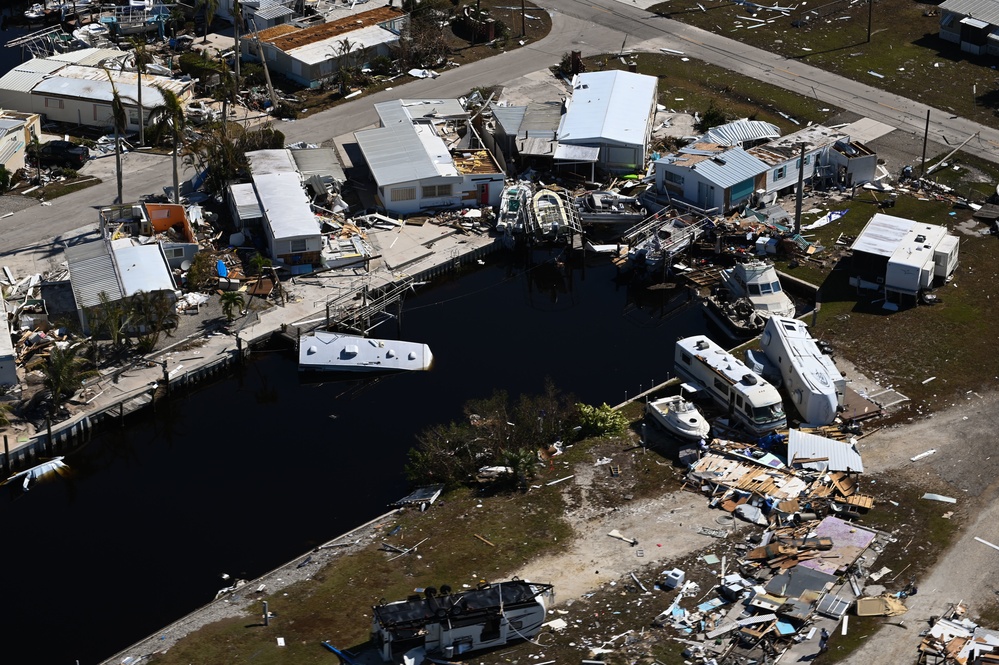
[621,212,713,274]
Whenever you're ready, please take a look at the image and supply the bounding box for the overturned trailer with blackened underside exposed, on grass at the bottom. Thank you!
[371,580,554,663]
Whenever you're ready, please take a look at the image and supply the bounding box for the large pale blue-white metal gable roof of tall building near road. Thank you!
[558,70,657,145]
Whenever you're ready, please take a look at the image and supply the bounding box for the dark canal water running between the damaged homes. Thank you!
[0,251,728,665]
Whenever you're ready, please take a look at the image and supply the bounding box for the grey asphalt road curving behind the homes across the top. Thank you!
[0,0,999,260]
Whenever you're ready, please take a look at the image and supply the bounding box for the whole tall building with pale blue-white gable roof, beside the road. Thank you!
[558,70,658,173]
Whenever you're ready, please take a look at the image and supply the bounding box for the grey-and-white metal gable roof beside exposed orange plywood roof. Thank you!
[354,121,446,187]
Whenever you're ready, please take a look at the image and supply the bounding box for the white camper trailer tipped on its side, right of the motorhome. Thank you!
[760,316,846,427]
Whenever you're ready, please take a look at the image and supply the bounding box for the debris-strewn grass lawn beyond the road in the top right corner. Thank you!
[649,0,999,127]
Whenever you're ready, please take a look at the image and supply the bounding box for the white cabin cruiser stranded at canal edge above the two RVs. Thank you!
[705,259,795,337]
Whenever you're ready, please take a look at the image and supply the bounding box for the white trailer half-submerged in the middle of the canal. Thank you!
[298,331,434,372]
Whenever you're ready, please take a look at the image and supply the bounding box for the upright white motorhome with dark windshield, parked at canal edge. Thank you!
[674,335,787,436]
